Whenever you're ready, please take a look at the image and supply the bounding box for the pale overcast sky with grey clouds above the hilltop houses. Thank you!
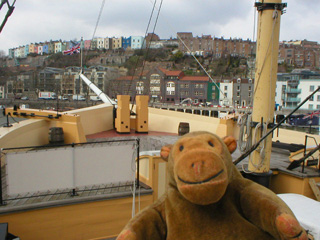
[0,0,320,54]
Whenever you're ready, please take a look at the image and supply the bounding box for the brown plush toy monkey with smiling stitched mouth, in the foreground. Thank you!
[117,132,307,240]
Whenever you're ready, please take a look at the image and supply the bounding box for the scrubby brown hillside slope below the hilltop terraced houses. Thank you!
[0,49,252,77]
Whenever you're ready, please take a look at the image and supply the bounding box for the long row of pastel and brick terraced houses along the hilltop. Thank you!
[9,32,320,69]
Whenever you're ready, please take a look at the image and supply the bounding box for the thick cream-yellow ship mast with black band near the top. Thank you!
[248,0,287,178]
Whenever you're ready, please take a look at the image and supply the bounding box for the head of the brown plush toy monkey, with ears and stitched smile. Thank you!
[161,132,237,205]
